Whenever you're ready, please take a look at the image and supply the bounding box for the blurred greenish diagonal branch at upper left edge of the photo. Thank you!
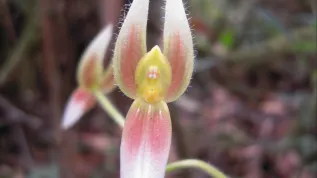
[0,5,39,85]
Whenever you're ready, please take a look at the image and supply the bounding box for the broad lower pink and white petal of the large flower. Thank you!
[120,100,172,178]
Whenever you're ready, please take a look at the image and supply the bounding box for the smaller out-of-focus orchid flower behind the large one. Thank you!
[62,25,115,129]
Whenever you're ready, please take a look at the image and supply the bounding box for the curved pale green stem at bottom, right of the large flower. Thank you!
[166,159,227,178]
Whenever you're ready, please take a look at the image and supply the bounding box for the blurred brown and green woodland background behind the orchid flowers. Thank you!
[0,0,317,178]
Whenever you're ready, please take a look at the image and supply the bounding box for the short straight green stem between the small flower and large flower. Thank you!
[94,91,125,128]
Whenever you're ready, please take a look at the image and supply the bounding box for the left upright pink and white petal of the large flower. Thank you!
[113,0,149,99]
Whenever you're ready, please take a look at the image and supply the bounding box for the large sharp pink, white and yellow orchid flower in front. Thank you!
[113,0,194,178]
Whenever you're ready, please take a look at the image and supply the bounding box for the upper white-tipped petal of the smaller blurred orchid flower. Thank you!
[77,25,113,89]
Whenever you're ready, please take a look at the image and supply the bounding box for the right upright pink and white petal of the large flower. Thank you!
[163,0,194,102]
